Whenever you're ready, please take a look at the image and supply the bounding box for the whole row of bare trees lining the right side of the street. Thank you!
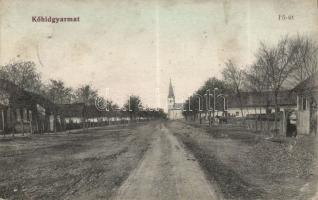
[184,35,318,127]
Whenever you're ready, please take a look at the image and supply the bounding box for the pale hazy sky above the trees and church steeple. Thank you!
[0,0,318,107]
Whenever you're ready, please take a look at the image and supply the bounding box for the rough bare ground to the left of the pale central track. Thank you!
[0,122,157,200]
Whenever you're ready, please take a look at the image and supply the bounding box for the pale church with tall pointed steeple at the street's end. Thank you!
[167,80,183,120]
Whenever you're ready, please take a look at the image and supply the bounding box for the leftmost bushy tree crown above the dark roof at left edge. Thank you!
[0,61,42,93]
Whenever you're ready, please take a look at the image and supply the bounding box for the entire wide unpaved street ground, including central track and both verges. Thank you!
[0,121,318,200]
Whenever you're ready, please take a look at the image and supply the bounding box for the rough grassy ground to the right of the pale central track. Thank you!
[168,122,318,200]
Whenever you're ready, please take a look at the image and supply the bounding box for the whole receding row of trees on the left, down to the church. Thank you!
[0,61,168,118]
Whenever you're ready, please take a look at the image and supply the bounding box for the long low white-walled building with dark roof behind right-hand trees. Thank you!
[227,90,297,117]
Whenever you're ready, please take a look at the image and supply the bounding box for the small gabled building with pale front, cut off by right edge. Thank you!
[293,73,318,135]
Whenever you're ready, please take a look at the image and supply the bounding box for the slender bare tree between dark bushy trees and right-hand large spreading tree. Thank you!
[222,60,244,116]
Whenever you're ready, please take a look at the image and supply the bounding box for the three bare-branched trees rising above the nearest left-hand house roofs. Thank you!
[0,61,97,104]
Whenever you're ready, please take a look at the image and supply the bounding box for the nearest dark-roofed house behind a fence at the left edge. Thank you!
[0,79,60,133]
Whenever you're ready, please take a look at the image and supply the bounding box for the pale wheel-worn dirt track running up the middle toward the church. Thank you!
[113,124,220,200]
